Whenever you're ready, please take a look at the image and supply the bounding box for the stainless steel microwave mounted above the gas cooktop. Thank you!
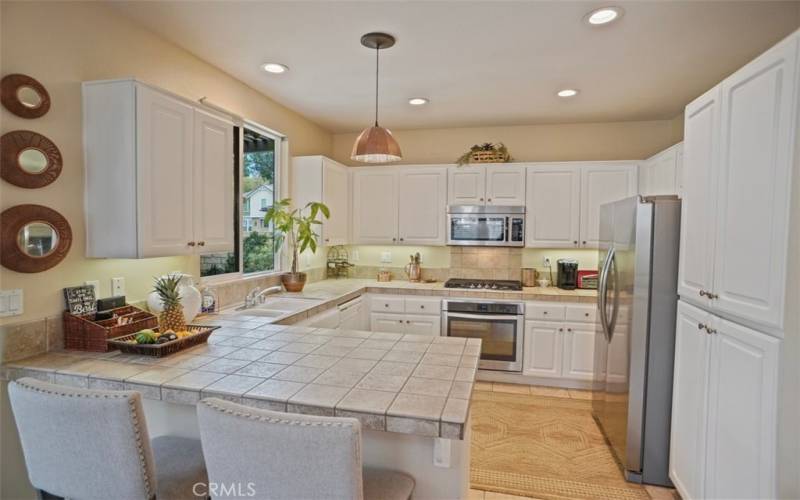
[447,205,525,247]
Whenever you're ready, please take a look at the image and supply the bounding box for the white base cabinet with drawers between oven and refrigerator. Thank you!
[522,302,600,381]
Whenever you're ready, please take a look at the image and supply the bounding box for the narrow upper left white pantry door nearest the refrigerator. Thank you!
[678,87,720,306]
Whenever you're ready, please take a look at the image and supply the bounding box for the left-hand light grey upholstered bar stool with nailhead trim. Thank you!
[8,378,207,500]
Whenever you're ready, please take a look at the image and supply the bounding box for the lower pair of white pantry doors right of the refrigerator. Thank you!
[670,302,780,498]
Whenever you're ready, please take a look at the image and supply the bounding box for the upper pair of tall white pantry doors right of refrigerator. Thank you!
[679,36,798,336]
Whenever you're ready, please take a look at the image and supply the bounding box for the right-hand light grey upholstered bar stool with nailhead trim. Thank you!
[197,398,414,500]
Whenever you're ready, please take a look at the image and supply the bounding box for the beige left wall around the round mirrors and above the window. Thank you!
[0,2,331,324]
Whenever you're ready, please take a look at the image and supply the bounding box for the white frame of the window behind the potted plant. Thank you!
[200,120,288,285]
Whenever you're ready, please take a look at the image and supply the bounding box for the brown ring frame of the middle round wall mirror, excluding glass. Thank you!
[0,130,63,189]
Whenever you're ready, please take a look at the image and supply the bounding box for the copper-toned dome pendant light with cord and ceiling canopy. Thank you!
[350,33,403,163]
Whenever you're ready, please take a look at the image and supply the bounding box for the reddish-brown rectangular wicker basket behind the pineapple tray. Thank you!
[64,306,158,352]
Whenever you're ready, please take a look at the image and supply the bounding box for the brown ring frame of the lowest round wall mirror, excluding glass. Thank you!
[0,205,72,273]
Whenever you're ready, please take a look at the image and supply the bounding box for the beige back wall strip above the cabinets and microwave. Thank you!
[333,116,683,165]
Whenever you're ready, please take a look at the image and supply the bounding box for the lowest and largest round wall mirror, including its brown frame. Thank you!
[0,205,72,273]
